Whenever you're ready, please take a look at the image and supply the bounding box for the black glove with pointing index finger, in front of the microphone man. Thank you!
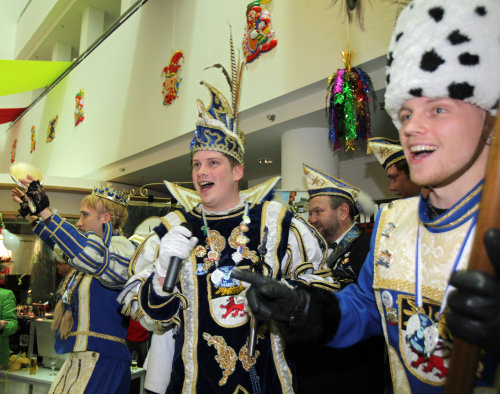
[231,268,310,326]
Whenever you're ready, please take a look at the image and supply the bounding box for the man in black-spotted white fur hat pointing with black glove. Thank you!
[236,0,500,393]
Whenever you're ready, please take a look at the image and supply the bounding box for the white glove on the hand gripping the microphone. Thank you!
[155,226,198,278]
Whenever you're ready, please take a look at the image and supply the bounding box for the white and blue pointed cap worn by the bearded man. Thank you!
[302,164,375,216]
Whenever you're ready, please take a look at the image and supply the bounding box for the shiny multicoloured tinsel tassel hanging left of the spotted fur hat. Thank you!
[326,51,376,151]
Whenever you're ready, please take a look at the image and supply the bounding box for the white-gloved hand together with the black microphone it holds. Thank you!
[155,222,198,293]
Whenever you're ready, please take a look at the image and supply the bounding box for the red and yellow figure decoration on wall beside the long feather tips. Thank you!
[243,0,278,63]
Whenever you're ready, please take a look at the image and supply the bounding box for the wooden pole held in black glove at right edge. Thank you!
[444,106,500,394]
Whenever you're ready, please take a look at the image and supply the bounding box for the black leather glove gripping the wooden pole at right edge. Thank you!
[446,229,500,355]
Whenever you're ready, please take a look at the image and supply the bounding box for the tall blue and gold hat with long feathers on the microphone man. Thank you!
[191,30,245,165]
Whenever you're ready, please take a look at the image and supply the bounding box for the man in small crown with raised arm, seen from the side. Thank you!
[13,183,135,393]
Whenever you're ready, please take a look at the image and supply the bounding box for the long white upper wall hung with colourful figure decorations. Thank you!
[0,0,395,186]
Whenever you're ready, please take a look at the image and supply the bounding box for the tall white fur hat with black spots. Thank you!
[385,0,500,128]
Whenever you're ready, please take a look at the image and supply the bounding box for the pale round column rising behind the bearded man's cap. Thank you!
[281,127,339,190]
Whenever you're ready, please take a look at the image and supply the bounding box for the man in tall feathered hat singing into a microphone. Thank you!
[121,57,329,394]
